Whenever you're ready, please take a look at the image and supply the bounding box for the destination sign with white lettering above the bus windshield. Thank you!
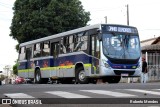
[102,26,138,33]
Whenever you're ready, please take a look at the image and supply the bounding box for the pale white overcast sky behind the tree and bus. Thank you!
[0,0,160,68]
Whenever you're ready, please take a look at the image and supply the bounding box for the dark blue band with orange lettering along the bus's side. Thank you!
[18,54,92,70]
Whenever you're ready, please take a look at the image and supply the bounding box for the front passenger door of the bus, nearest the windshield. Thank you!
[91,35,100,74]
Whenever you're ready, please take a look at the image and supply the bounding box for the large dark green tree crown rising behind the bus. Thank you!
[10,0,90,43]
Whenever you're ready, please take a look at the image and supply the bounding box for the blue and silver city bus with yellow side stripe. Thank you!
[18,24,142,84]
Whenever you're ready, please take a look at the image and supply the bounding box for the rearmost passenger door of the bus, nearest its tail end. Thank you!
[25,47,32,78]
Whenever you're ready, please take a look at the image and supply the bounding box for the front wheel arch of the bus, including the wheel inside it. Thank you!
[75,63,89,84]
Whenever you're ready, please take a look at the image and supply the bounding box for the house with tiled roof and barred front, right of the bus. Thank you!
[141,37,160,81]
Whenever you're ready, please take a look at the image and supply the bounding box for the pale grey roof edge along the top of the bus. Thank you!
[20,24,136,47]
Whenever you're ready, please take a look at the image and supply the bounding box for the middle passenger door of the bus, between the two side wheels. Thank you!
[51,42,59,78]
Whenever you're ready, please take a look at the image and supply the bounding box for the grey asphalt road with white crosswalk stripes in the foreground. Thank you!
[0,83,160,107]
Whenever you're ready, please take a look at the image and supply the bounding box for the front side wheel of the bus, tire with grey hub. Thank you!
[76,67,89,84]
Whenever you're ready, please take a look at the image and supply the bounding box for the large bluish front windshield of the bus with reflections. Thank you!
[102,33,140,59]
